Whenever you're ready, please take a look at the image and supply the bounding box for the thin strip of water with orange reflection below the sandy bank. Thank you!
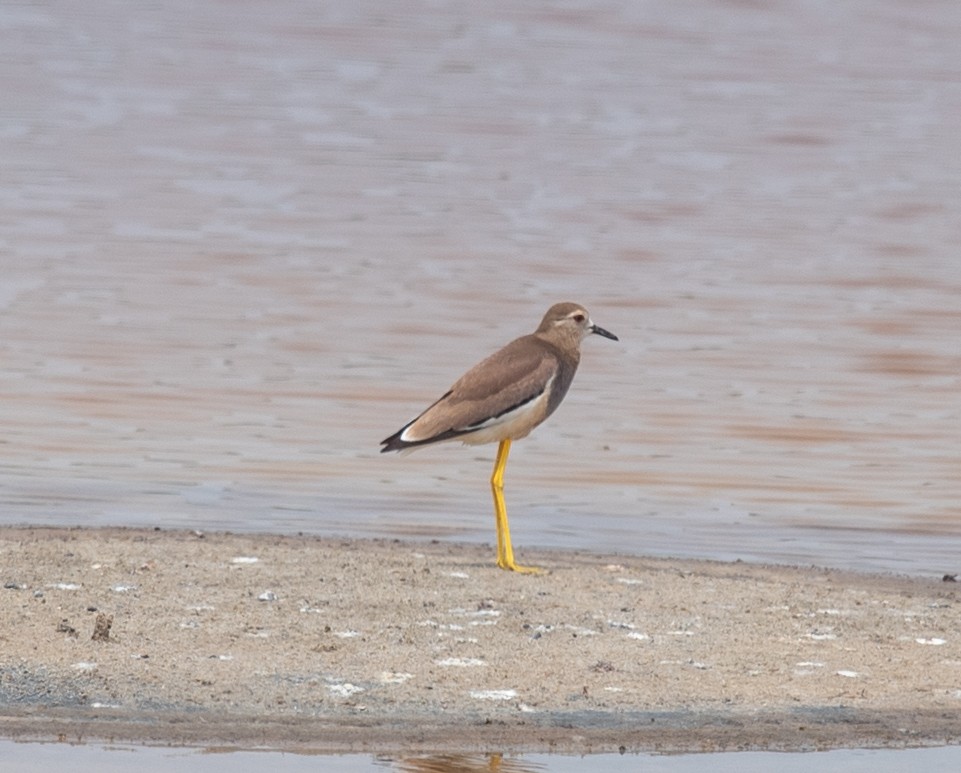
[0,741,961,773]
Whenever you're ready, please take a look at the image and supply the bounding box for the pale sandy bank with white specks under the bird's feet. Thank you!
[0,528,961,752]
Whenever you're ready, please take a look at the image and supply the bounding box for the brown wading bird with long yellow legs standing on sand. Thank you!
[380,302,619,574]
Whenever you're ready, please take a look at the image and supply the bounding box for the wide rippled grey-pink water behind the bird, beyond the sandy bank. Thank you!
[0,0,961,577]
